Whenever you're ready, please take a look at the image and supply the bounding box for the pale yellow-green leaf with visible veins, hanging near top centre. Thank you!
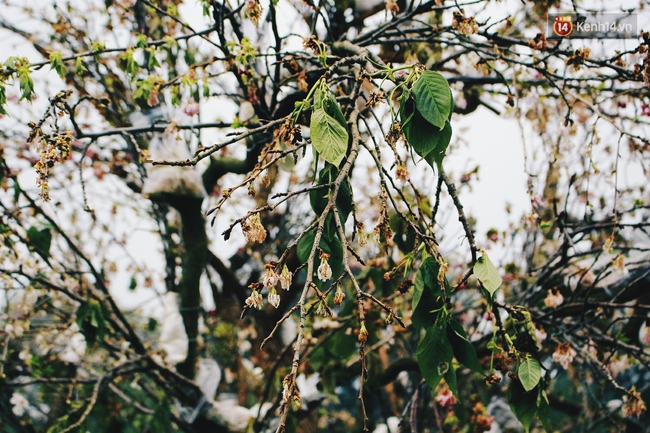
[310,108,349,167]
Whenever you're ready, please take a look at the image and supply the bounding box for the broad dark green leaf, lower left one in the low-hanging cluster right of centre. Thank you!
[417,326,454,389]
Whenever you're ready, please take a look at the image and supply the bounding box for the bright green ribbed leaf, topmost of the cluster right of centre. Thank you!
[413,71,453,130]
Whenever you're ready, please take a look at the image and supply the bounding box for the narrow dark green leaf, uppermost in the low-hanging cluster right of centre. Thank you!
[411,257,442,329]
